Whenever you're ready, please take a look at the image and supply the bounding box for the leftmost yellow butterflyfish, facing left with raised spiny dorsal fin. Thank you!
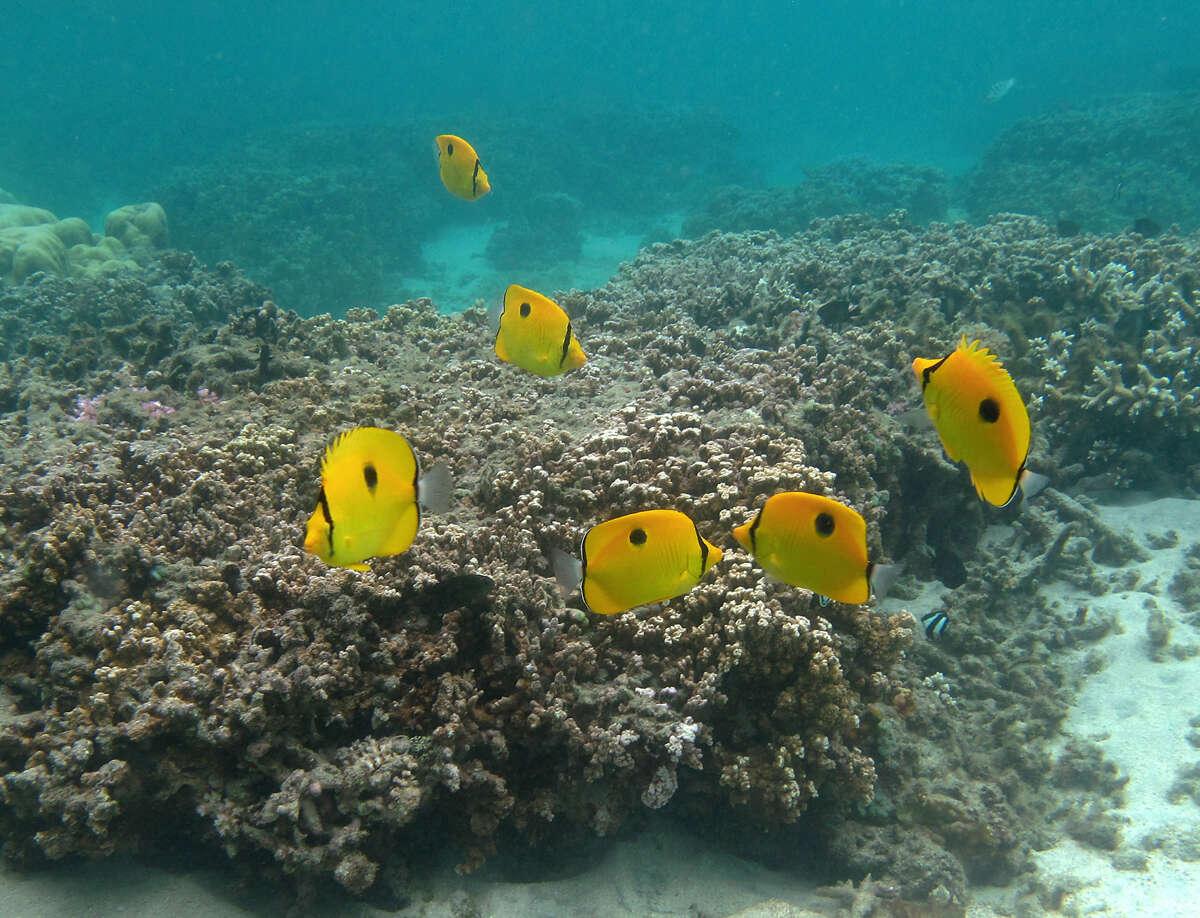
[304,427,454,570]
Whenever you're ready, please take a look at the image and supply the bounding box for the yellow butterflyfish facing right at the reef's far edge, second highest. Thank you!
[487,283,587,377]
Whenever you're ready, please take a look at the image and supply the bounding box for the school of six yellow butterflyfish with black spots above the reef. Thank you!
[305,134,1046,637]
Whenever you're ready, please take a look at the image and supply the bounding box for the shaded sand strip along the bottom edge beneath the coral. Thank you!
[0,822,832,918]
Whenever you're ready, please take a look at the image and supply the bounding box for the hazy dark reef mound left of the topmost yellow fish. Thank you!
[151,124,439,314]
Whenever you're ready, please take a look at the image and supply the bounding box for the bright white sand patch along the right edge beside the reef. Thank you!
[1038,498,1200,918]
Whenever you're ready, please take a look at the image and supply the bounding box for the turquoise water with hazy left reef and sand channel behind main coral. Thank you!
[0,0,1200,314]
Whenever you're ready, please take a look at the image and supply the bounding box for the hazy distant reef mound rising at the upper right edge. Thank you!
[965,91,1200,235]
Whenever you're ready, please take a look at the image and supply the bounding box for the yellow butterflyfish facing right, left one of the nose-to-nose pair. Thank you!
[552,510,721,616]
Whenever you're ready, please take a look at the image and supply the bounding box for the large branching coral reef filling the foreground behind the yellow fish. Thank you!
[0,216,1198,913]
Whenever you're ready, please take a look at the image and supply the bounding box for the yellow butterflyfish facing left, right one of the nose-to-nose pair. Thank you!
[733,491,899,604]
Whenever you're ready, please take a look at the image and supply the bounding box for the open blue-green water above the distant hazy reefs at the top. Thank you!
[0,0,1200,217]
